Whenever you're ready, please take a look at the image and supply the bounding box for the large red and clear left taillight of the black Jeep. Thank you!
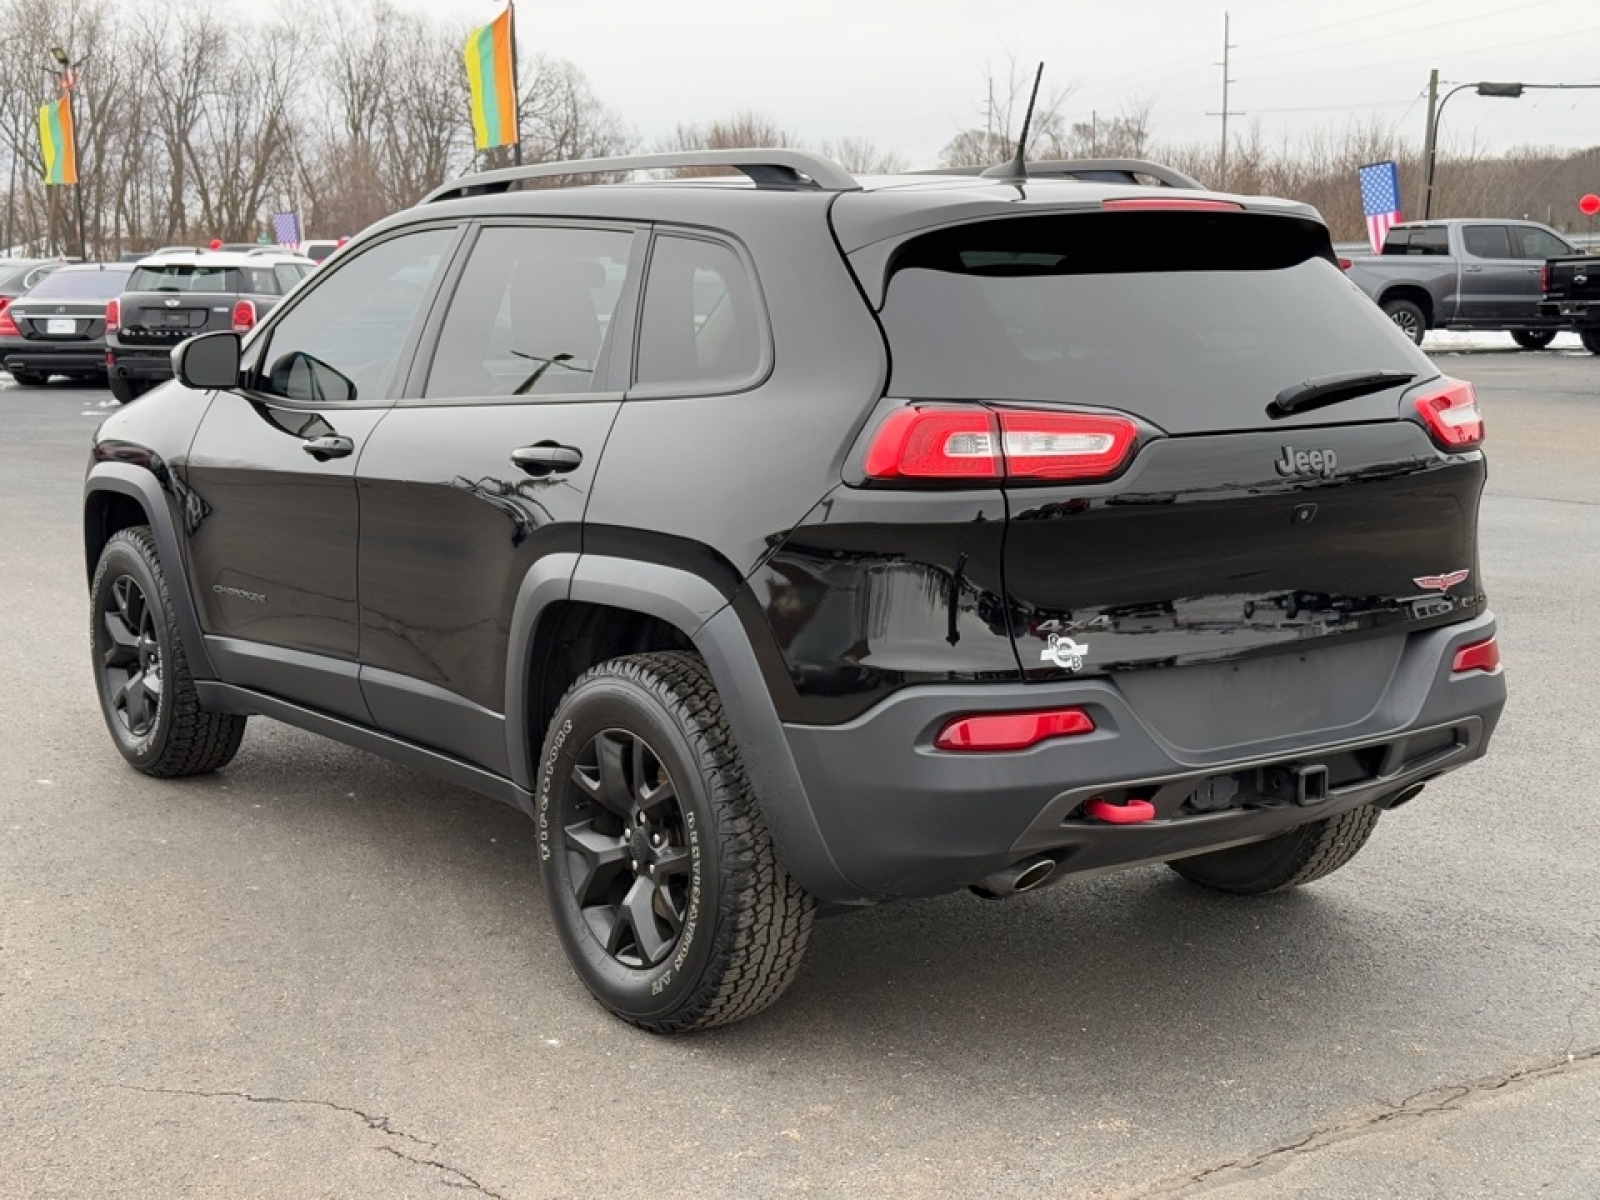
[864,408,1139,480]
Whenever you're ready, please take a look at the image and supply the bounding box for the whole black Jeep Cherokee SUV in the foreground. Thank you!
[85,150,1504,1032]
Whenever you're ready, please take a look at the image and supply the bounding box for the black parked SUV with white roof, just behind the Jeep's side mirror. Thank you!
[104,246,314,403]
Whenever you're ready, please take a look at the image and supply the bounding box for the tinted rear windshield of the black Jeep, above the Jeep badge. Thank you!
[883,213,1435,434]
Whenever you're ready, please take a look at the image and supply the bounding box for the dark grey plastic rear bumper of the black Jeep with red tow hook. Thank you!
[786,616,1506,899]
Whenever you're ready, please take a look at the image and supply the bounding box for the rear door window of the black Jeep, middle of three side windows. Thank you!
[424,226,634,398]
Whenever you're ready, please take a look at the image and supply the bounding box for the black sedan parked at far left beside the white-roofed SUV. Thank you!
[0,262,131,387]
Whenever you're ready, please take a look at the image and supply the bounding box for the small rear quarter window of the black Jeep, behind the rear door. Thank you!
[635,237,762,389]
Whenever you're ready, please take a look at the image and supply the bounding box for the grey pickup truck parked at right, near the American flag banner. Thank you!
[1341,219,1578,350]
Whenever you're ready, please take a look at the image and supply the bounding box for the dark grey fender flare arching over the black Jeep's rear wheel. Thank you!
[506,554,862,901]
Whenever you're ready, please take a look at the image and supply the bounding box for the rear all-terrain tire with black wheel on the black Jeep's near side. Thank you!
[536,651,816,1034]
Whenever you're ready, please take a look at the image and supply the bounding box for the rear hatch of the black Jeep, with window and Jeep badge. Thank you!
[882,211,1485,744]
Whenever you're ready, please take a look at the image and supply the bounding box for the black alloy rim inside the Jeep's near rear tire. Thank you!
[562,730,691,970]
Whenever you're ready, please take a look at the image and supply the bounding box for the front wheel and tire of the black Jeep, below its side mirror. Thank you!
[90,525,245,779]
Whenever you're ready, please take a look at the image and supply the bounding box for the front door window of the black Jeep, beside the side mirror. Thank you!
[251,229,456,403]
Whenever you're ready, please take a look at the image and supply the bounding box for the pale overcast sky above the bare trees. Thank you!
[291,0,1600,169]
